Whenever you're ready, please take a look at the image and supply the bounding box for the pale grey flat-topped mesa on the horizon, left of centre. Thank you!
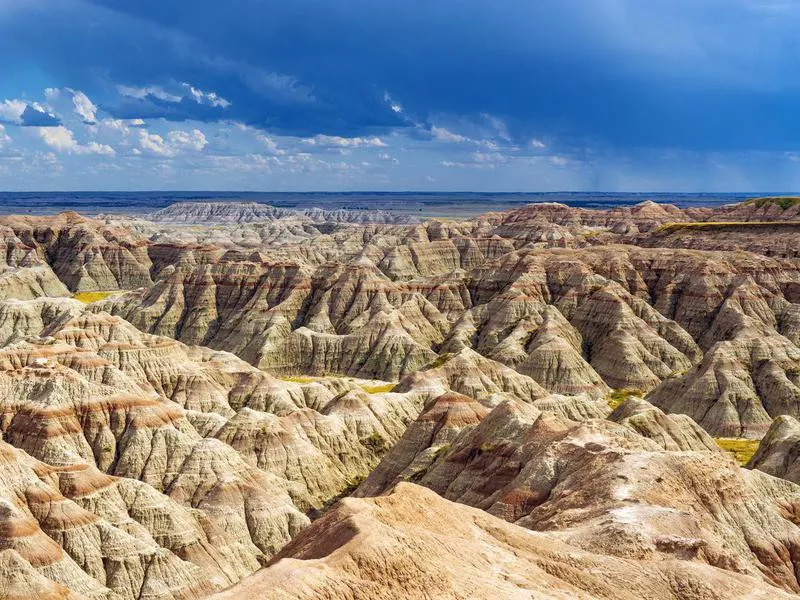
[145,201,419,225]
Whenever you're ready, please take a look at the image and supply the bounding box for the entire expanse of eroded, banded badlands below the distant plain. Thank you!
[0,198,800,600]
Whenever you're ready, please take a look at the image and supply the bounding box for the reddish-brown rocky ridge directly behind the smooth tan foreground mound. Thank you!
[355,401,800,592]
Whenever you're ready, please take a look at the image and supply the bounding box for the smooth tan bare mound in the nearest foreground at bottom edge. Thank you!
[211,483,792,600]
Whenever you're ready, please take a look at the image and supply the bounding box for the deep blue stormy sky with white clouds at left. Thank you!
[0,0,800,192]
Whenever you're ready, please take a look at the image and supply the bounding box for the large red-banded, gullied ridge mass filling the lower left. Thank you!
[0,299,422,600]
